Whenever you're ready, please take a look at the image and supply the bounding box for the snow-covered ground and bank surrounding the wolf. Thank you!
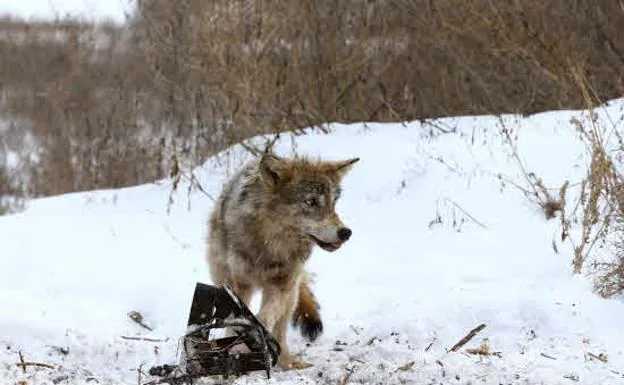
[0,100,624,385]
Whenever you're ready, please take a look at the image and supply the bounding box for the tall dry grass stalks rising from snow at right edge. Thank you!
[502,67,624,297]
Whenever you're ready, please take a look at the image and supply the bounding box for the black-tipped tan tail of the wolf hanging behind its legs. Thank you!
[292,273,323,341]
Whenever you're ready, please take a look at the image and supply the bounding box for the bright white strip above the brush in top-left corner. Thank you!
[0,0,135,23]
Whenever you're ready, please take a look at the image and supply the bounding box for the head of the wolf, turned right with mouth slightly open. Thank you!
[260,154,359,251]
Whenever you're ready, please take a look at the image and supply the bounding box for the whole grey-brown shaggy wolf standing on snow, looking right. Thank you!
[206,152,360,370]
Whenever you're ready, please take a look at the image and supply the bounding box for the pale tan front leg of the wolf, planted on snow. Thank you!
[258,280,312,370]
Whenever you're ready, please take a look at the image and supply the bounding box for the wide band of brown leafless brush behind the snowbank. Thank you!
[0,0,624,195]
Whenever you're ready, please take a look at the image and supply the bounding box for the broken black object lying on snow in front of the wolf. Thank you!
[146,282,280,385]
